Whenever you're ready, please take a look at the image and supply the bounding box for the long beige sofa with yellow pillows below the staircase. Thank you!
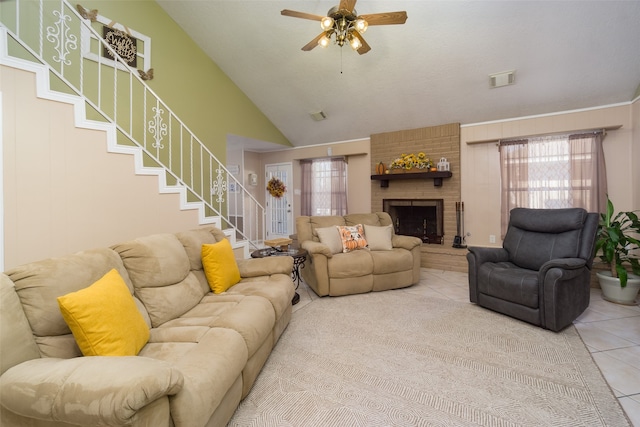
[0,227,294,427]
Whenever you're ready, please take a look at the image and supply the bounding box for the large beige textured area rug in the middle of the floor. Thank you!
[229,290,630,427]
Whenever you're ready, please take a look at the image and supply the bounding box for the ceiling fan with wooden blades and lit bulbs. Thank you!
[280,0,407,55]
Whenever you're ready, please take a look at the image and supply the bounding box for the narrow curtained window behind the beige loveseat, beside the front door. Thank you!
[300,158,347,216]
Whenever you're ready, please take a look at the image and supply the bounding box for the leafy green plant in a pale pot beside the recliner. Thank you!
[595,198,640,304]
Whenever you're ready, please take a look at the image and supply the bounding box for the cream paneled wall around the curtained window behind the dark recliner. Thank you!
[460,103,640,246]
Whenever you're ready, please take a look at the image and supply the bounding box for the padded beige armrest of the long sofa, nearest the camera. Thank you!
[0,356,184,426]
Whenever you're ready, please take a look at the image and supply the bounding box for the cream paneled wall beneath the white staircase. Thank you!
[0,66,204,269]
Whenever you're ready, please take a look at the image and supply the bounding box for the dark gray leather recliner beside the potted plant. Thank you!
[467,208,598,332]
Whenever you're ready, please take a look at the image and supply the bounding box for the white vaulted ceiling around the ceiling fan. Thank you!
[157,0,640,149]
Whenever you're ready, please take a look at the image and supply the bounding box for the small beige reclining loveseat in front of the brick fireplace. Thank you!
[296,212,422,296]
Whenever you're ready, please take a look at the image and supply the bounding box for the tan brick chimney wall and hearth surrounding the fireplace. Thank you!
[371,123,467,272]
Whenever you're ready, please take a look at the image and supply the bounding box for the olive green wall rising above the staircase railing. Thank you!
[80,0,292,162]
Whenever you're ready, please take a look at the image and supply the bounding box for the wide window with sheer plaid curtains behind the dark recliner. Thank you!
[500,132,607,236]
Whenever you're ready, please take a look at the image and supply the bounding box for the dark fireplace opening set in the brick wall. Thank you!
[382,199,444,245]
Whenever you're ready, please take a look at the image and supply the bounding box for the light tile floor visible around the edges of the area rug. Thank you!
[293,268,640,427]
